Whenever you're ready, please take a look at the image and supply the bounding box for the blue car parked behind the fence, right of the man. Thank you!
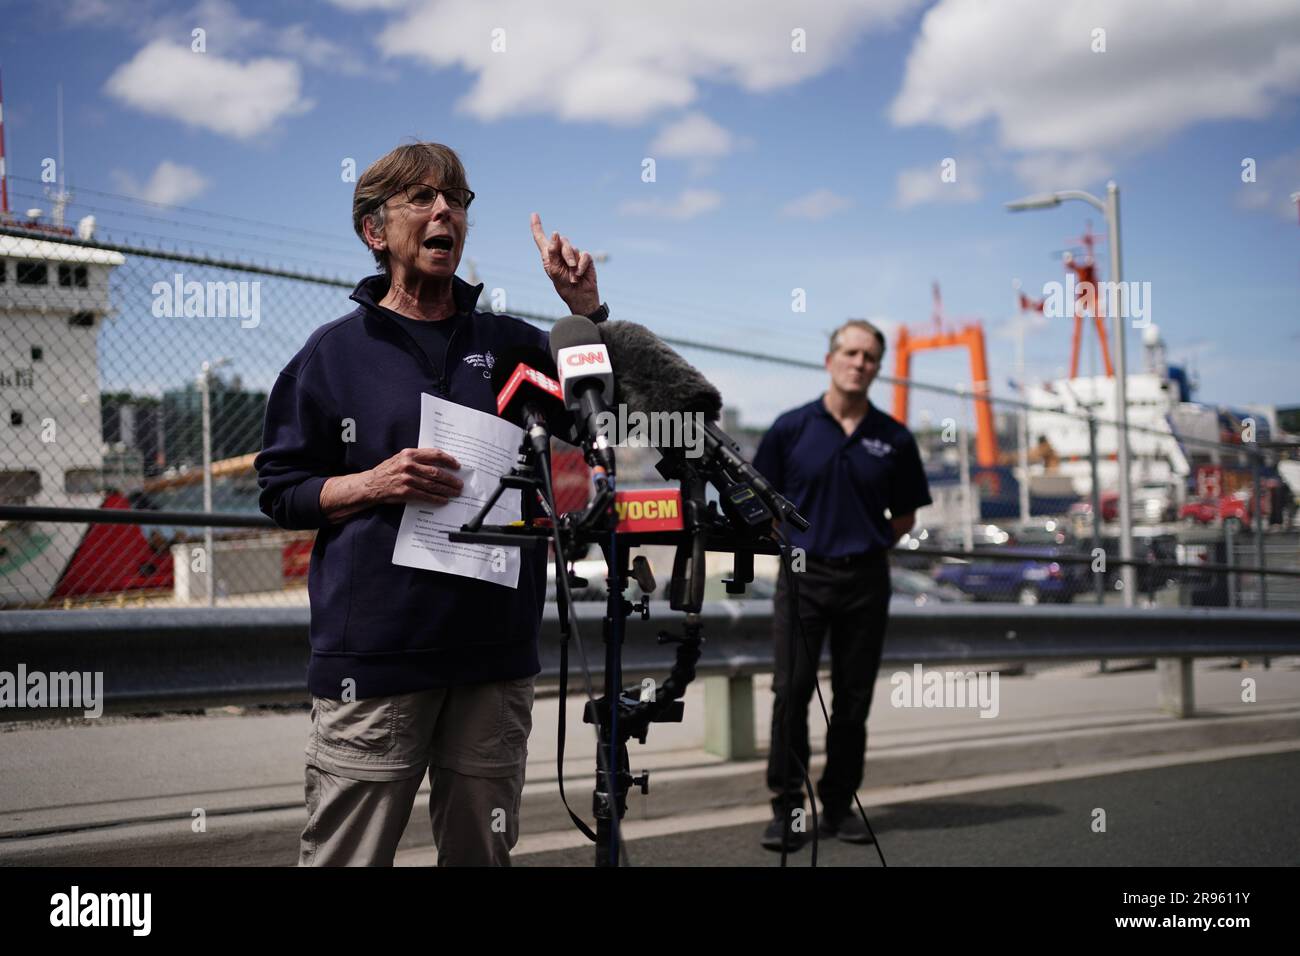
[935,546,1091,605]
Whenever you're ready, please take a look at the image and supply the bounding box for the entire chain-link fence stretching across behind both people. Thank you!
[0,224,1300,607]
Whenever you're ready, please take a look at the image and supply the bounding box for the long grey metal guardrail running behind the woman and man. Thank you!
[0,600,1300,713]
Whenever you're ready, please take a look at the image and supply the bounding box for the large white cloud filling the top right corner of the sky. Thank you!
[891,0,1300,185]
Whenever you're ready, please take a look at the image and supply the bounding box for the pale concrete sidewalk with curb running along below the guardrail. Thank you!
[0,658,1300,865]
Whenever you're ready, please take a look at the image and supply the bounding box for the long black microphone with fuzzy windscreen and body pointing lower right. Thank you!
[598,321,809,531]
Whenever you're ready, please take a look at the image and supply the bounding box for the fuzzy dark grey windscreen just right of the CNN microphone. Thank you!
[597,321,723,421]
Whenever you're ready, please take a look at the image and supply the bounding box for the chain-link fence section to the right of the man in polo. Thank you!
[891,352,1300,607]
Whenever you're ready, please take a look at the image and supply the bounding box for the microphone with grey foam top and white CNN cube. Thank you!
[550,315,614,481]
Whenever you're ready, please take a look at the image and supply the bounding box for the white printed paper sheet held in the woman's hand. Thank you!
[393,393,524,588]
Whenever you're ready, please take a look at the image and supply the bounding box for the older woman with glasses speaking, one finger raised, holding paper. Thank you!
[255,143,608,865]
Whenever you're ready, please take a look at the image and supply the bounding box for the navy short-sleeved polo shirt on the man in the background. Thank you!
[754,398,933,558]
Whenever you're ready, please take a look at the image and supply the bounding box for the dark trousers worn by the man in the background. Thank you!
[767,553,891,816]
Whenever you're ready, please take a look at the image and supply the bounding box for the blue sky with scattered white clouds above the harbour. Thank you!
[0,0,1300,421]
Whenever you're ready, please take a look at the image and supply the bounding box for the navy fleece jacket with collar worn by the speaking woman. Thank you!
[254,276,547,700]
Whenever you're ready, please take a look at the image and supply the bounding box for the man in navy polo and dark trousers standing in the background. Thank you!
[754,319,932,851]
